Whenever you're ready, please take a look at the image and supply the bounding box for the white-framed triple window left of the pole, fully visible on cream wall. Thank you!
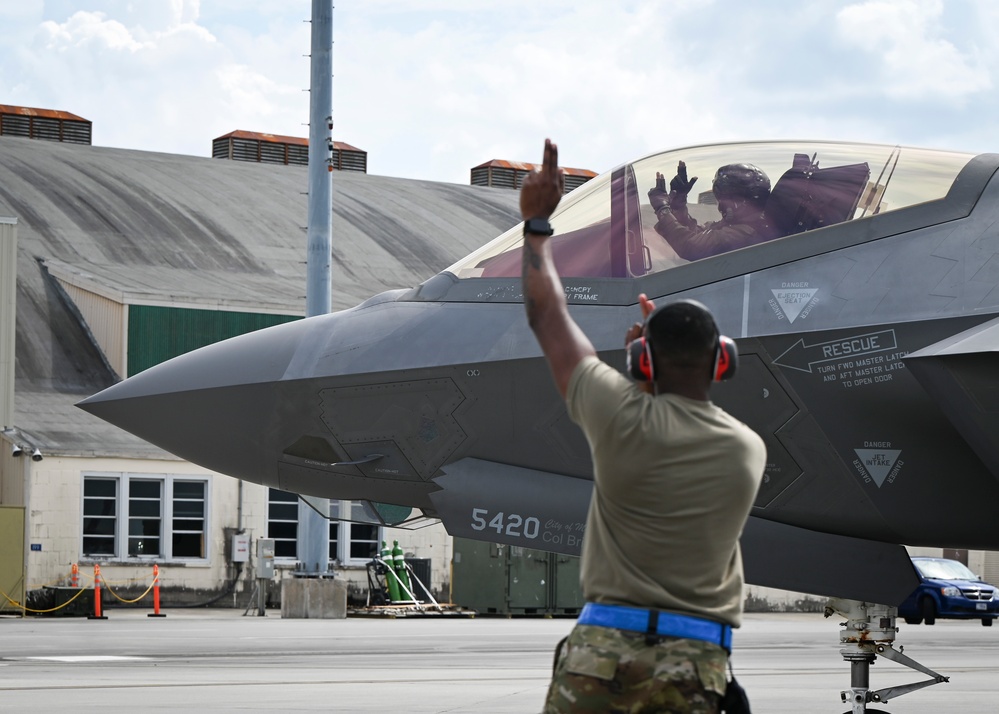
[82,474,208,561]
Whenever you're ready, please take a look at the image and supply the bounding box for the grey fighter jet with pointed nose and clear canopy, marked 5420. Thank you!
[81,141,999,711]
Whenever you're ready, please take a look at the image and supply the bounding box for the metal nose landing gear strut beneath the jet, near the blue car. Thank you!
[825,598,950,714]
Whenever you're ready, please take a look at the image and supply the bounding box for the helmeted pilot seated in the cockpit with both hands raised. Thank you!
[649,161,777,260]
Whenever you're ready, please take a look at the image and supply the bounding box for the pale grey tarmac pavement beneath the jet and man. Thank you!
[0,610,999,714]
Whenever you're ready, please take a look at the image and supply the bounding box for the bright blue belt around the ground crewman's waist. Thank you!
[576,602,732,652]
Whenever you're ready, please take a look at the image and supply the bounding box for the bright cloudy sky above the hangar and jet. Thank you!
[0,0,999,183]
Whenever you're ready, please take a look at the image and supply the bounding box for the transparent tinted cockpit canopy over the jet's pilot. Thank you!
[446,141,974,279]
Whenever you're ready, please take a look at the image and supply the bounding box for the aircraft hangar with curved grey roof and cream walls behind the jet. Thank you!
[0,126,519,611]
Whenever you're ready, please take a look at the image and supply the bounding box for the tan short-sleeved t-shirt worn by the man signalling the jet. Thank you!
[566,357,766,626]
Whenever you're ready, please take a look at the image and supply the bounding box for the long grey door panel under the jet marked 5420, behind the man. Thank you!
[430,458,919,605]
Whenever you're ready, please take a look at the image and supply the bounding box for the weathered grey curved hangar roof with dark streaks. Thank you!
[0,137,519,457]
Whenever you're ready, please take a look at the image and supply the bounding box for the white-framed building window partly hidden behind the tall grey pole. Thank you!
[267,488,382,565]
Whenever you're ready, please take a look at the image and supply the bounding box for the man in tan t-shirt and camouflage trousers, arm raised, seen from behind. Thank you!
[520,141,766,714]
